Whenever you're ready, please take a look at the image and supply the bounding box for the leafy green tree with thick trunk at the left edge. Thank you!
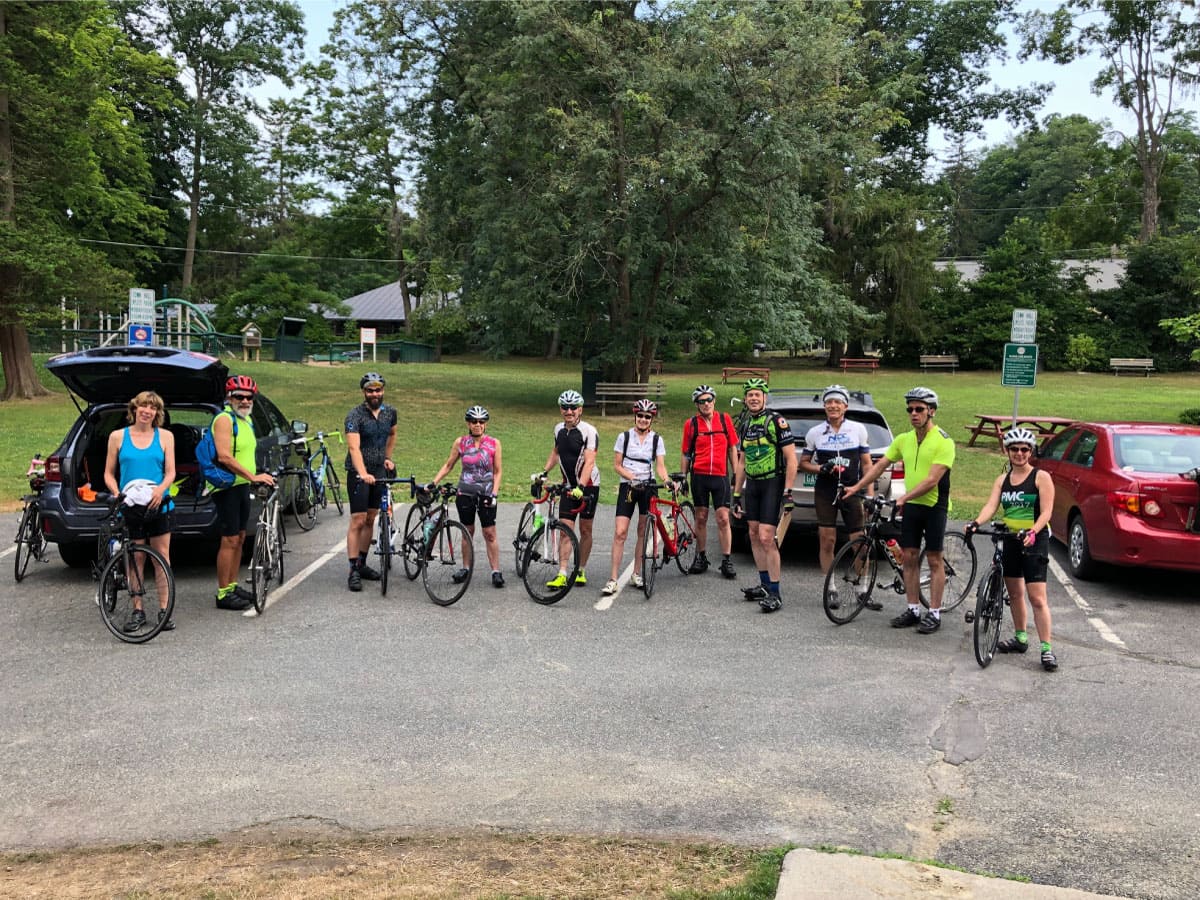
[0,2,172,400]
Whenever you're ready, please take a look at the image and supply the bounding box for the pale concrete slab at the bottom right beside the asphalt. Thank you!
[775,850,1128,900]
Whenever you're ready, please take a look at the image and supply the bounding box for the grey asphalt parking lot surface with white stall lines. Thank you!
[0,504,1200,900]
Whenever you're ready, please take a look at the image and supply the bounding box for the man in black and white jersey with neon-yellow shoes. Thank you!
[541,390,600,588]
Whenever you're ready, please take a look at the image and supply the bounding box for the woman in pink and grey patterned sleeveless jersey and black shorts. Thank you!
[433,406,504,588]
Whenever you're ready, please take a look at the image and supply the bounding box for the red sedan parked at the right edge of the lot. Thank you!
[1037,422,1200,578]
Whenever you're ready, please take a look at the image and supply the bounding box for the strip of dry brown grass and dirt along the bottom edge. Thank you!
[0,823,760,900]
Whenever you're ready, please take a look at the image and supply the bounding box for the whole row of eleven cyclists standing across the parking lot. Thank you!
[98,372,1058,671]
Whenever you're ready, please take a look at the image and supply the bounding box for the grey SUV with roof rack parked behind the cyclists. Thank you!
[731,388,904,532]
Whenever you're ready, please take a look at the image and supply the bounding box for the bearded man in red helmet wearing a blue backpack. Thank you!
[210,376,275,611]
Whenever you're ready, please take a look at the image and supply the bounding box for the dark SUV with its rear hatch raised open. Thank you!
[42,347,302,566]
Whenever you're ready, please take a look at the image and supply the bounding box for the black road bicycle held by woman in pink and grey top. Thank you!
[401,482,475,606]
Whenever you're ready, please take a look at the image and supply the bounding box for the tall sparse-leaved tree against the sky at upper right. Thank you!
[1022,0,1200,244]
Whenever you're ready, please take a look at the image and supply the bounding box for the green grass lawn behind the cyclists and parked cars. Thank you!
[0,356,1200,518]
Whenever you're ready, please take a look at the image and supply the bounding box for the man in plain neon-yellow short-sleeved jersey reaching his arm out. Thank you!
[846,388,954,635]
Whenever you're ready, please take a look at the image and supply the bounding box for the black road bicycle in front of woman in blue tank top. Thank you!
[95,493,175,643]
